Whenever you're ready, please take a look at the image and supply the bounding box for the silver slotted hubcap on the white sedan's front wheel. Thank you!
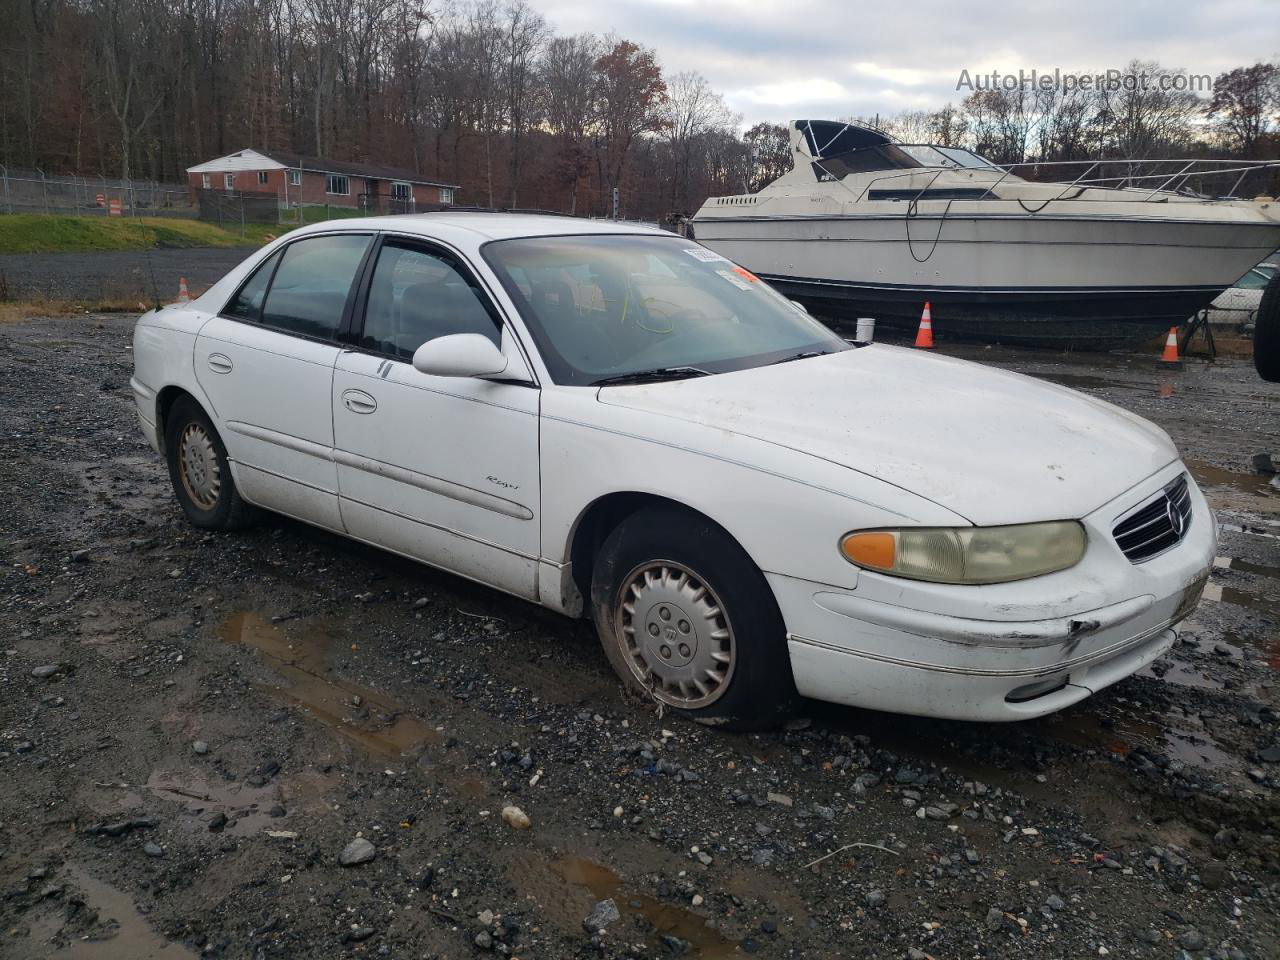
[617,561,733,709]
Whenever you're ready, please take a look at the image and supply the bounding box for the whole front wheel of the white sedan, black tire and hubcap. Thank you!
[591,506,796,731]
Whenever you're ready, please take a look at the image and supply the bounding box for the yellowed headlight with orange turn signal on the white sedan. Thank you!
[840,520,1084,584]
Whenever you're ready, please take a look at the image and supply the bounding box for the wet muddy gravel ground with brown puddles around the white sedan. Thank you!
[0,317,1280,960]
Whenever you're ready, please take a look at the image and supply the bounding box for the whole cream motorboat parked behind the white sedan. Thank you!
[692,120,1280,347]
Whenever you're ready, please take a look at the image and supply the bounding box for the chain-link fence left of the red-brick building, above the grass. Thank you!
[0,164,196,218]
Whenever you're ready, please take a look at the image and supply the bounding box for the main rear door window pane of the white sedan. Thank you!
[262,234,369,340]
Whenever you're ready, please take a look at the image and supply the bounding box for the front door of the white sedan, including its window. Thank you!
[333,238,539,598]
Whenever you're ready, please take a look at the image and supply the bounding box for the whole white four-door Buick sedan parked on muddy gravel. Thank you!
[132,214,1216,730]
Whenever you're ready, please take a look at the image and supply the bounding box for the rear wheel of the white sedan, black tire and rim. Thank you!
[164,397,257,530]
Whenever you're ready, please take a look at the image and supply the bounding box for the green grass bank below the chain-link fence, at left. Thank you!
[0,214,288,253]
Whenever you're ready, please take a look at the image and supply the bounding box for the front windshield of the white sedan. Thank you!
[484,234,849,385]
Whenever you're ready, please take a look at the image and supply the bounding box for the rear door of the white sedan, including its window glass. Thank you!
[196,233,371,530]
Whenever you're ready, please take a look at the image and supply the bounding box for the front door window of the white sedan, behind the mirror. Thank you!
[360,241,500,360]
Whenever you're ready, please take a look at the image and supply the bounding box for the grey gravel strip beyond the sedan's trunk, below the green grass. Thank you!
[0,246,259,303]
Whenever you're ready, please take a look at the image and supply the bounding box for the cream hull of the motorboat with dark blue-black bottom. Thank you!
[695,212,1280,348]
